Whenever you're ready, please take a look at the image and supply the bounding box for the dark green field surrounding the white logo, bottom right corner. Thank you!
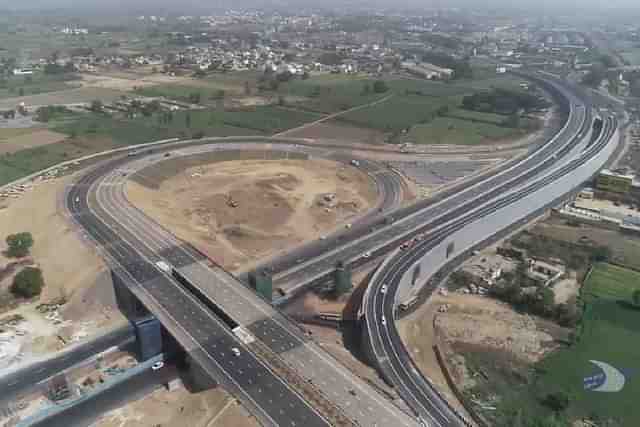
[536,299,640,427]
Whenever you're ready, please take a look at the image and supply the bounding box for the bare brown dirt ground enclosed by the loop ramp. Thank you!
[126,159,377,270]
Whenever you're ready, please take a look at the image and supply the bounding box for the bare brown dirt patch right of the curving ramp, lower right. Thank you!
[398,293,559,414]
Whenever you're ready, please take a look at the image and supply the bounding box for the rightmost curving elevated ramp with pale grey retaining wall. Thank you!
[364,109,617,426]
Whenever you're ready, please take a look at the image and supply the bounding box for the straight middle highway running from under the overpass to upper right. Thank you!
[266,74,592,303]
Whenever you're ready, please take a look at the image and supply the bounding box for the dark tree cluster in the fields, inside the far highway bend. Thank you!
[462,88,548,114]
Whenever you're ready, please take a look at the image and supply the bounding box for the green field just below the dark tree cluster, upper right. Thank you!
[403,117,521,145]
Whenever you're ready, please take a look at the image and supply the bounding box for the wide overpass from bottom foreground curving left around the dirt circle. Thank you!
[66,144,416,426]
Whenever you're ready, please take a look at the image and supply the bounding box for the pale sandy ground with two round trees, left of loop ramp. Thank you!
[0,172,125,362]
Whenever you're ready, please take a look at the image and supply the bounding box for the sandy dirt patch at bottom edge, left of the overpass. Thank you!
[94,387,259,427]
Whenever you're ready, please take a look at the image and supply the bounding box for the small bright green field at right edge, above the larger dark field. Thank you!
[582,263,640,301]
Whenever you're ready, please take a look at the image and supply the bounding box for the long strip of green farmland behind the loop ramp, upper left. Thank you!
[0,107,319,185]
